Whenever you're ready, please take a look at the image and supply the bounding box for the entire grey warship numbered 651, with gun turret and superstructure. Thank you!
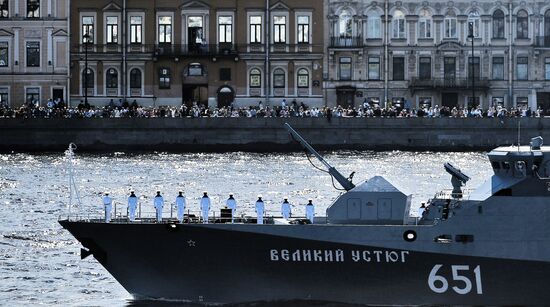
[59,124,550,306]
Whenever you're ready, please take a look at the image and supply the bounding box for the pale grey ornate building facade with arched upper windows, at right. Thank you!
[323,0,550,109]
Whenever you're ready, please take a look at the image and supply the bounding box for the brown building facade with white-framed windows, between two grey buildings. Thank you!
[70,0,325,107]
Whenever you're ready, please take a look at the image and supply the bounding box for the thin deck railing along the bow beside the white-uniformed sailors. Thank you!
[59,202,327,224]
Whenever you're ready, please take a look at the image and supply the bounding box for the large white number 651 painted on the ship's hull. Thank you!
[428,264,483,295]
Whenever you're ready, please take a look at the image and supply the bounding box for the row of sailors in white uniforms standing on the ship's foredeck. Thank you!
[103,191,315,224]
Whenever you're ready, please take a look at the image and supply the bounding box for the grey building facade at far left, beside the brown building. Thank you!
[0,0,69,107]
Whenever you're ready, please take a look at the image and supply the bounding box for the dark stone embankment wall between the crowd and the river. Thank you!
[0,118,550,152]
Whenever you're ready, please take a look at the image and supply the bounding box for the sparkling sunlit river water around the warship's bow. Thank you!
[0,151,491,306]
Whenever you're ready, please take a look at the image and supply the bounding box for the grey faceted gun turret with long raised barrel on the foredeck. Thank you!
[285,124,411,225]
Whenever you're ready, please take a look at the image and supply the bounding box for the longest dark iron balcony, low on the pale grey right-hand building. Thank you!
[409,78,489,90]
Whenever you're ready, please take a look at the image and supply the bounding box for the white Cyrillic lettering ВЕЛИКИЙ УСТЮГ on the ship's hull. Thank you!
[269,249,409,263]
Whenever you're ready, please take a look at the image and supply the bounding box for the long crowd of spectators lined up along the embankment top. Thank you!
[0,99,550,120]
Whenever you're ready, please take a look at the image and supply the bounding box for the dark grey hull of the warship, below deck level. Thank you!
[60,221,550,305]
